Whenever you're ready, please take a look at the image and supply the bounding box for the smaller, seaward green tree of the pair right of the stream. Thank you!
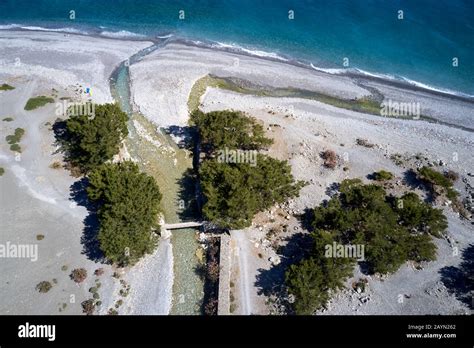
[191,110,273,152]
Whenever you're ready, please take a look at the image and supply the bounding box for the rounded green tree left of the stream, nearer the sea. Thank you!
[62,104,128,172]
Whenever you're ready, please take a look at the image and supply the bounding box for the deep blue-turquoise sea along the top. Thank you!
[0,0,474,95]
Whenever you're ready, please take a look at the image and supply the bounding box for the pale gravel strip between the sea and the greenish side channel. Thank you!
[131,40,474,132]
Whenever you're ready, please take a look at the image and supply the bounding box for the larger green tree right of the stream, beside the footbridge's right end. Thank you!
[199,154,301,229]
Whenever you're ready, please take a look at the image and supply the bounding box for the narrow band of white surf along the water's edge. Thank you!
[0,24,474,100]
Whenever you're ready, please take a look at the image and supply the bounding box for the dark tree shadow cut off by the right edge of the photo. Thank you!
[439,244,474,310]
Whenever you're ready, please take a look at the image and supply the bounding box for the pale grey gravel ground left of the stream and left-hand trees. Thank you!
[0,31,151,314]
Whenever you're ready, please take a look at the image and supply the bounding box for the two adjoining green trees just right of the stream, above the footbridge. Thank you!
[191,110,302,229]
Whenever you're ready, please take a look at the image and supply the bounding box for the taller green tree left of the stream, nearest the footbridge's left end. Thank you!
[87,162,161,265]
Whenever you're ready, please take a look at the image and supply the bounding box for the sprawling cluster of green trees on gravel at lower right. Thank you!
[286,179,447,314]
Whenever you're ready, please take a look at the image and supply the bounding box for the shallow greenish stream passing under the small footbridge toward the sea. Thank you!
[110,43,204,315]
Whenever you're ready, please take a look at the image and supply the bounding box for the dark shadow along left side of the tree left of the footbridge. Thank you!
[70,177,106,263]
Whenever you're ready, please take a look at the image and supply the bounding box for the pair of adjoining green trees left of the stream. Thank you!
[61,104,161,266]
